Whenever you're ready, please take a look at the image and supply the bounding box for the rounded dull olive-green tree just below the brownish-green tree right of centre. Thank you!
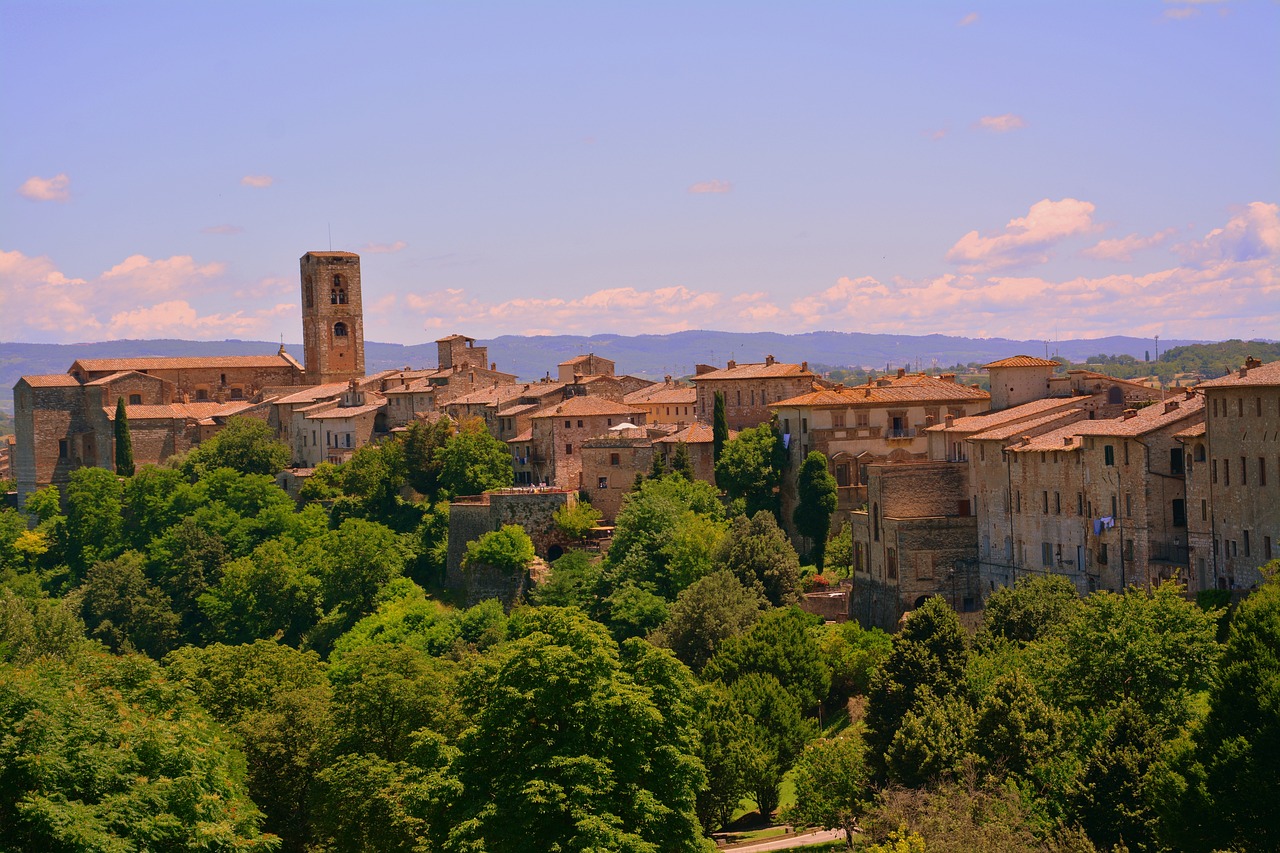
[649,571,768,672]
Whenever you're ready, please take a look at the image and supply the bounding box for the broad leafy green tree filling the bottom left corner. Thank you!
[0,652,278,853]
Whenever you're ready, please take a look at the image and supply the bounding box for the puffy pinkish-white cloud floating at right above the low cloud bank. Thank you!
[947,199,1096,273]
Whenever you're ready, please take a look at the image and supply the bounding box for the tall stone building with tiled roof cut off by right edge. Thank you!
[1178,359,1280,589]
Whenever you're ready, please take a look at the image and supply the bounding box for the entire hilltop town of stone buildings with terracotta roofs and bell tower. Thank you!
[13,251,1280,628]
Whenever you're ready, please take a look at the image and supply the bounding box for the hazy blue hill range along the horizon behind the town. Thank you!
[0,332,1223,411]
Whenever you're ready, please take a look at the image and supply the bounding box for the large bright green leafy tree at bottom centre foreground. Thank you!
[449,608,709,853]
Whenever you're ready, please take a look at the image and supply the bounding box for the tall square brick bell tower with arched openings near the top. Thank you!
[301,252,365,386]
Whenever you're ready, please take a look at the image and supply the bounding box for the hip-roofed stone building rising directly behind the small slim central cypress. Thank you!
[691,356,827,429]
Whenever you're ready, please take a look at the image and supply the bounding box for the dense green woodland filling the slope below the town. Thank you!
[0,419,1280,853]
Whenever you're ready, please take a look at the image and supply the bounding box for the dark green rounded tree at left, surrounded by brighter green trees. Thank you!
[79,551,179,658]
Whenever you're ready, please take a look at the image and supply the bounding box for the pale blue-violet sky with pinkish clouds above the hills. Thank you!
[0,0,1280,345]
